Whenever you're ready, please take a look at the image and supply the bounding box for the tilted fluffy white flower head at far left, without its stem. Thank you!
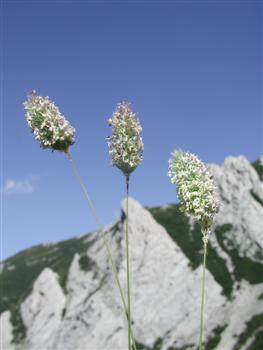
[24,91,75,153]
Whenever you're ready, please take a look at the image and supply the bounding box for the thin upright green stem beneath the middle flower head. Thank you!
[125,175,131,350]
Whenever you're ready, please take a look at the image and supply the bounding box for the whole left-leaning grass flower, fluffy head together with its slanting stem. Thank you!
[24,91,136,350]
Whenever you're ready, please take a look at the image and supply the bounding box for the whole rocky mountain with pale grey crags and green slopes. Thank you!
[0,156,263,350]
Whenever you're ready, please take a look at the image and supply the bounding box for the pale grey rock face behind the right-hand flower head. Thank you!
[211,156,263,260]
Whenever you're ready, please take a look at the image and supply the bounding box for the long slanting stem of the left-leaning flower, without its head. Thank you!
[66,151,137,350]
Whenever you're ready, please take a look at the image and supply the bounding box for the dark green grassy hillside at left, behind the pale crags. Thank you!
[0,235,94,342]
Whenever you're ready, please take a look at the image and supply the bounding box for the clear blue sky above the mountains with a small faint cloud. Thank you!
[1,0,263,257]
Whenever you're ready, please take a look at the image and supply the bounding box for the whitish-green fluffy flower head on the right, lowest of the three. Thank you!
[168,150,219,231]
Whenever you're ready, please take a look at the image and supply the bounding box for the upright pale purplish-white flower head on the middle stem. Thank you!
[107,102,144,176]
